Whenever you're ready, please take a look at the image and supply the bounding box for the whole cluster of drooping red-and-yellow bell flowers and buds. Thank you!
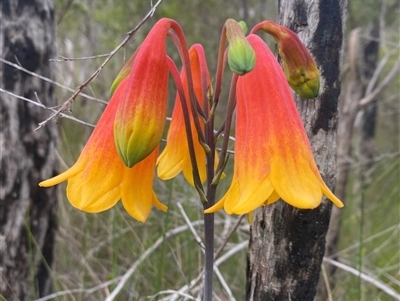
[39,19,343,222]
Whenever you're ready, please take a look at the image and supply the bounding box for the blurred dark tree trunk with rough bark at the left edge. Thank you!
[0,0,57,301]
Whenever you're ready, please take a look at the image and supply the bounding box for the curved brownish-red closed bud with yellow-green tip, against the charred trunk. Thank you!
[252,21,319,99]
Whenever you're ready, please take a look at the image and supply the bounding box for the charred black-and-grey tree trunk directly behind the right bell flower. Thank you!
[246,0,347,301]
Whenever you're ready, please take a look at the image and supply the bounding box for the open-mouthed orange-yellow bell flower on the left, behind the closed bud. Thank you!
[39,78,167,222]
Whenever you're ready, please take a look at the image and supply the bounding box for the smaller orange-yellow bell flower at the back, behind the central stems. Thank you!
[157,44,218,185]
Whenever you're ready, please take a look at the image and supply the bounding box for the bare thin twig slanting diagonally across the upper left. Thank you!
[37,0,163,129]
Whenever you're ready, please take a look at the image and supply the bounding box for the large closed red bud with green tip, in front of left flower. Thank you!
[114,19,171,167]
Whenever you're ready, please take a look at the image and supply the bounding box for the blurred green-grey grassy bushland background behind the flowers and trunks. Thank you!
[39,0,400,300]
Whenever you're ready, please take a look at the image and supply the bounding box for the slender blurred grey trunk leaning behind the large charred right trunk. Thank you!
[317,24,379,301]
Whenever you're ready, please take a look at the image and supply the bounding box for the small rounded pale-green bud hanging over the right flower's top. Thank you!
[228,40,256,75]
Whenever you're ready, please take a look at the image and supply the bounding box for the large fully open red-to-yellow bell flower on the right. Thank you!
[205,34,343,214]
